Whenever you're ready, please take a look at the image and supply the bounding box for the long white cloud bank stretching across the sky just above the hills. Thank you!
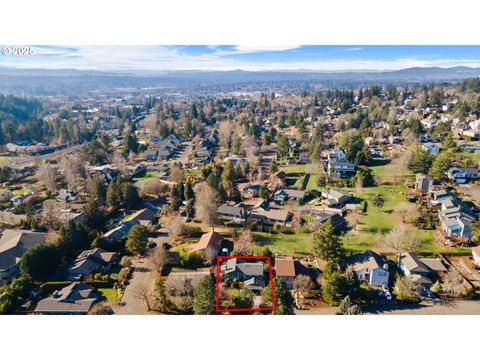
[0,46,480,71]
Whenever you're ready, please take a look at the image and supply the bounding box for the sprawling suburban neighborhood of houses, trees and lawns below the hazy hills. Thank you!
[0,51,480,315]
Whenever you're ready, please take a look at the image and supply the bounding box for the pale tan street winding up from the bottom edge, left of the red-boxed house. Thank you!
[114,216,183,315]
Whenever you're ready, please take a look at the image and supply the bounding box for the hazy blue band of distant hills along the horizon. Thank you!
[0,66,480,96]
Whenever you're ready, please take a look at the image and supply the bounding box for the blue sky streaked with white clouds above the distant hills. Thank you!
[0,45,480,71]
